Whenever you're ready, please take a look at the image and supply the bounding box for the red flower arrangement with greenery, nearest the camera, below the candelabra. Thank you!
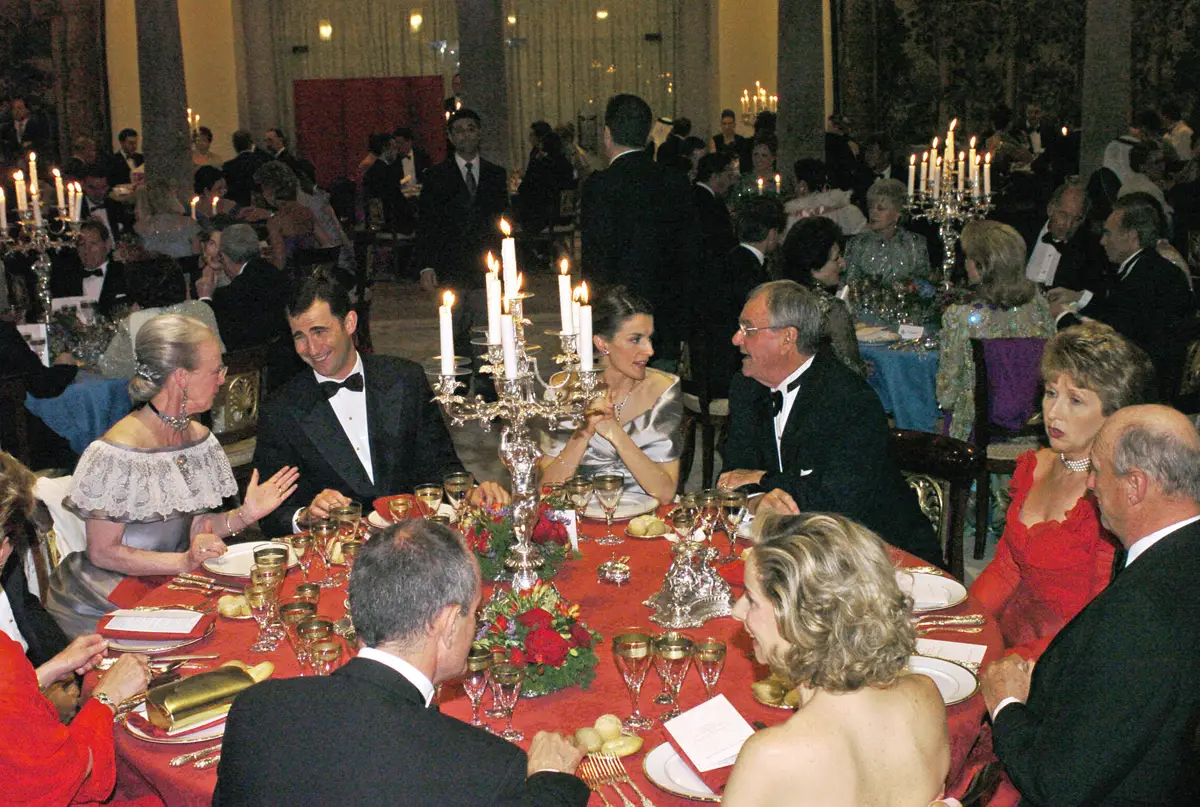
[475,582,600,698]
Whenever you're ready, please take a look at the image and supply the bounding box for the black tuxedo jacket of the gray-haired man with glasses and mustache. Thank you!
[721,349,944,566]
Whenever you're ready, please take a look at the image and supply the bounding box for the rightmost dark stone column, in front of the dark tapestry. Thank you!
[1079,0,1133,178]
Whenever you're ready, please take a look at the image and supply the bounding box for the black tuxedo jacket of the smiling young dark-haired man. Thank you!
[252,355,462,534]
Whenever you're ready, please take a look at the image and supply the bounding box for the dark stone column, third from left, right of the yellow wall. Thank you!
[778,0,826,171]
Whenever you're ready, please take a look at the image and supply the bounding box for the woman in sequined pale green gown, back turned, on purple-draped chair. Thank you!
[937,221,1054,440]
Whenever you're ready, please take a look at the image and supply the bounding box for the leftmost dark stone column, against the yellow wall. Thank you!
[135,0,190,192]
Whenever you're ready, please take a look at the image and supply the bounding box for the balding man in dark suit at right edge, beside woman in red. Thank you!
[982,406,1200,807]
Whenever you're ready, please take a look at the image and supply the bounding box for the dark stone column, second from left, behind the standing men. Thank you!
[446,0,509,166]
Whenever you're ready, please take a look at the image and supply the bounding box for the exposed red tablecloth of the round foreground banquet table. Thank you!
[100,506,1003,807]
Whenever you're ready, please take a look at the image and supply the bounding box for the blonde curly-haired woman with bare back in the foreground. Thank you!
[721,513,950,807]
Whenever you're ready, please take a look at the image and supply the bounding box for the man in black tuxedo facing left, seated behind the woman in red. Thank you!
[1049,193,1195,400]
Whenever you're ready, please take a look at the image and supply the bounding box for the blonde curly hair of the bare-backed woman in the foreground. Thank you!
[751,513,917,692]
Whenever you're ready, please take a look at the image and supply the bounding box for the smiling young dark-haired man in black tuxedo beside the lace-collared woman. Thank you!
[253,272,509,534]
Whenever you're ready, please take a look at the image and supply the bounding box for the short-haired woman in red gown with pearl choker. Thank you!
[971,321,1153,659]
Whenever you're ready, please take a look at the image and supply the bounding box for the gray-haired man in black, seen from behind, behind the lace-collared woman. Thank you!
[196,225,289,351]
